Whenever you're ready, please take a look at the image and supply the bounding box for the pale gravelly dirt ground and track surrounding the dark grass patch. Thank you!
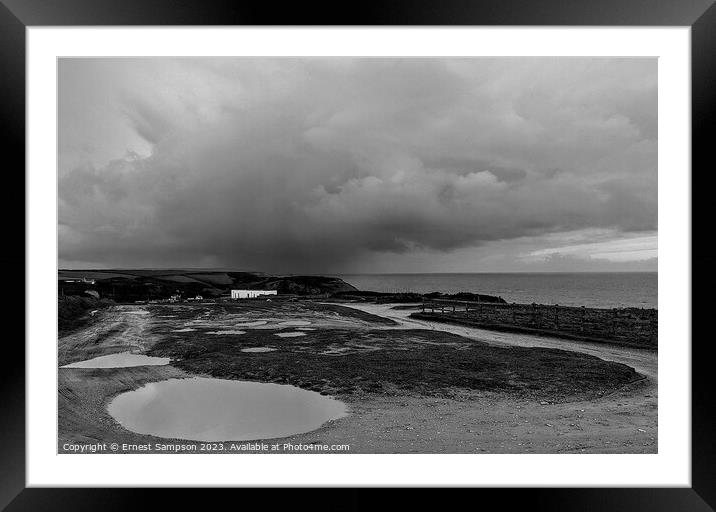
[58,304,658,453]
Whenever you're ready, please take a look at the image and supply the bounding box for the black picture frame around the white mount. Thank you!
[0,0,716,511]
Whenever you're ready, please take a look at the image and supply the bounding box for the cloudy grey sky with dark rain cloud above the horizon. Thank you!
[58,57,657,273]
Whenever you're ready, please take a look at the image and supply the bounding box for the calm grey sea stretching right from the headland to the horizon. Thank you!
[337,272,658,308]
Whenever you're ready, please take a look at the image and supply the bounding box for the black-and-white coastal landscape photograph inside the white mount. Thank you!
[57,55,668,457]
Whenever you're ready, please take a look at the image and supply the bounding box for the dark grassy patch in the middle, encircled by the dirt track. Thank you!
[148,302,638,401]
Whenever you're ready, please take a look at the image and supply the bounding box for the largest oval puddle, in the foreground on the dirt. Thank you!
[107,377,347,441]
